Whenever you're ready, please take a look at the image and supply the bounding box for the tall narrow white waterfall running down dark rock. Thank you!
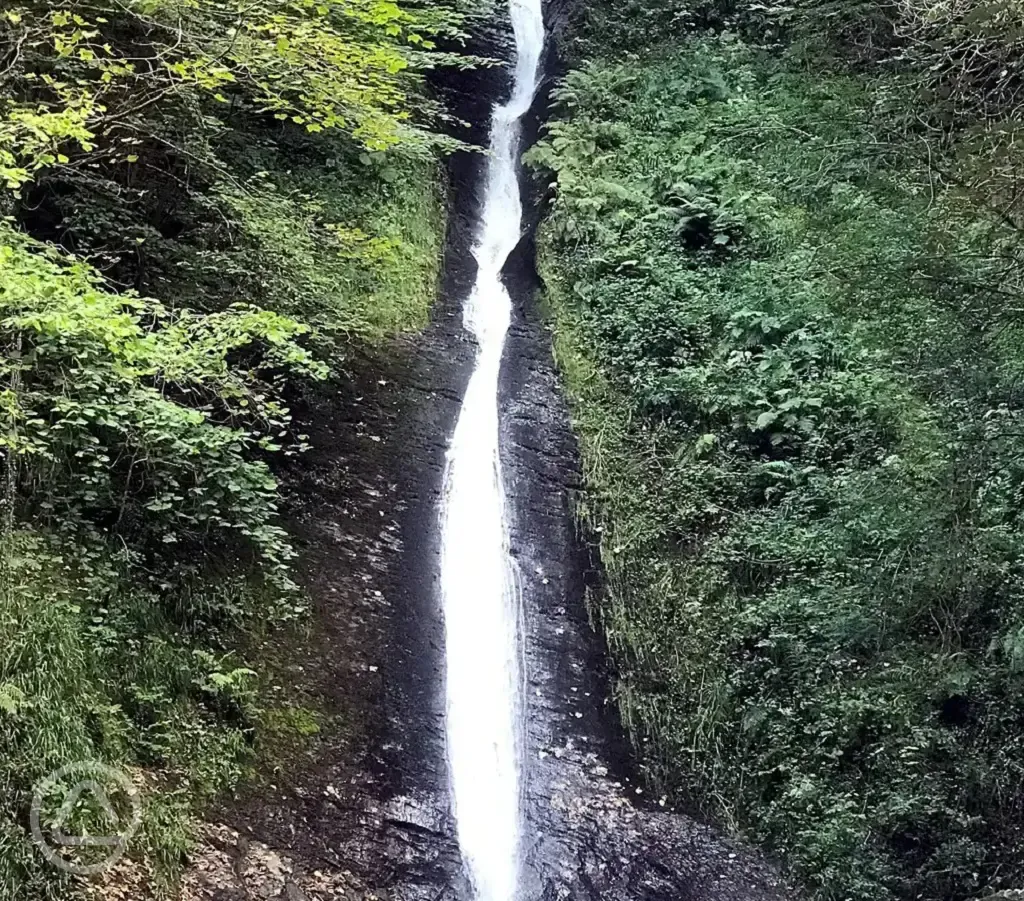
[441,0,544,901]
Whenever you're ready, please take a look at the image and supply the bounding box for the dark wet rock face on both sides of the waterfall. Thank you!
[183,3,786,901]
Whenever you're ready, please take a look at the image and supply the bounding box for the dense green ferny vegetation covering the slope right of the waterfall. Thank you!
[530,0,1024,901]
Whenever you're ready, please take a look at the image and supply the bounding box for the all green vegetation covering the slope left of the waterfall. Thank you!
[0,0,477,888]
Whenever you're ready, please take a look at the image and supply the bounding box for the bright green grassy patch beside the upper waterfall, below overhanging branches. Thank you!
[205,141,445,346]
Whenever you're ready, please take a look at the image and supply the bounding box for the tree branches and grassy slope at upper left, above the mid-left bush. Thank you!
[0,0,458,342]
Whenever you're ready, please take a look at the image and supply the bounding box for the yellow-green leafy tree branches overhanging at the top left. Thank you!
[0,0,471,187]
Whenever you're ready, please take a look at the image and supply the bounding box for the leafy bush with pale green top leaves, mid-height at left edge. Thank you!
[0,222,325,578]
